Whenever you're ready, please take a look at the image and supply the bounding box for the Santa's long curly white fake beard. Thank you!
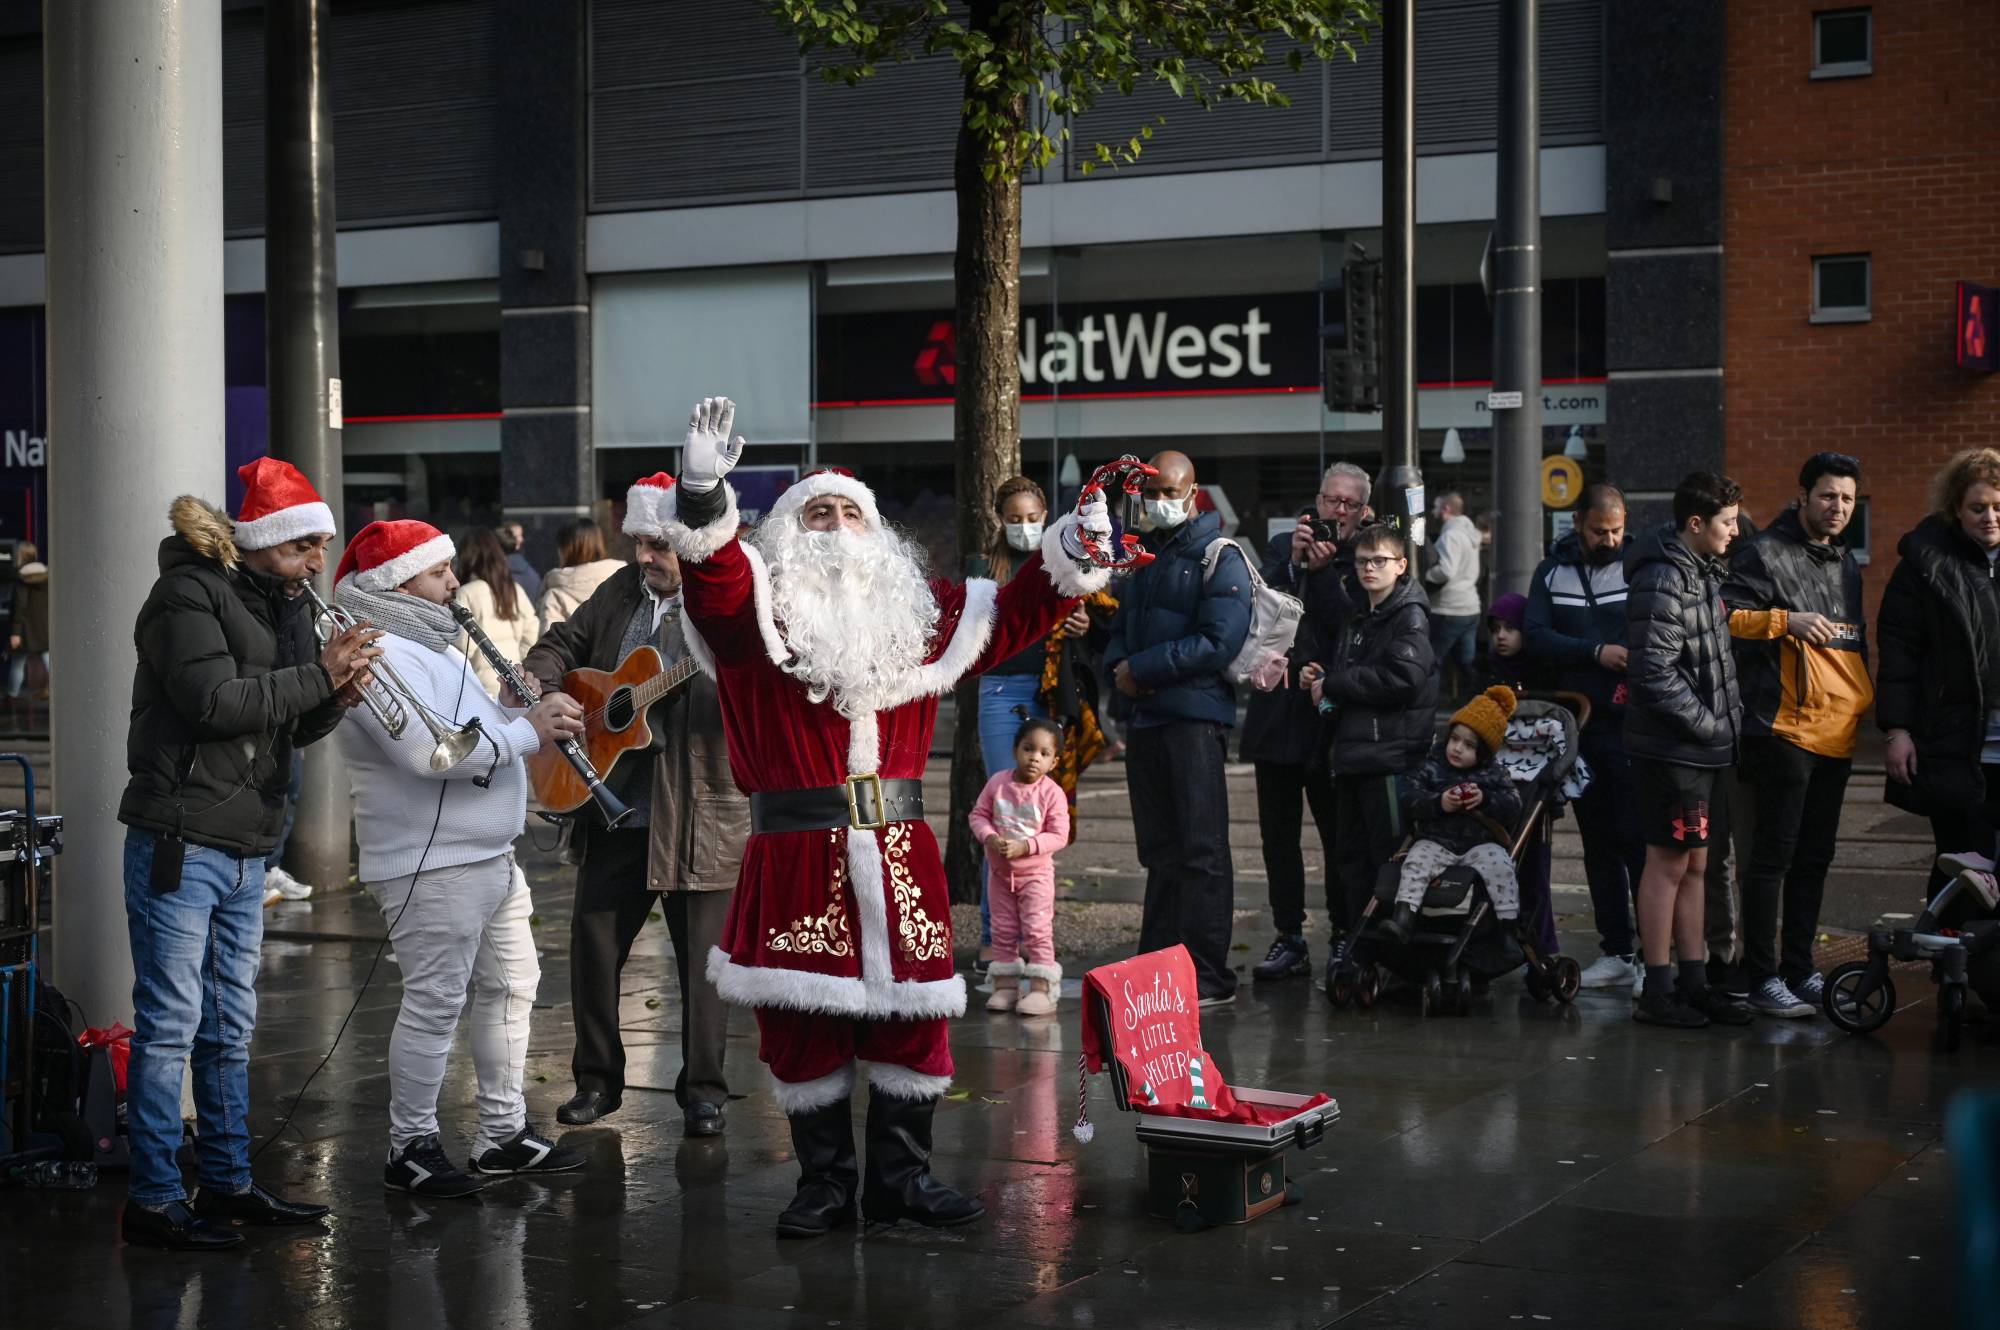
[752,514,938,718]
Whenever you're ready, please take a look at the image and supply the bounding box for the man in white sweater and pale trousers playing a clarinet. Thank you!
[334,522,584,1196]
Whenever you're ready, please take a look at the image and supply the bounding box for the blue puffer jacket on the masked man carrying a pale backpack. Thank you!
[1104,512,1250,730]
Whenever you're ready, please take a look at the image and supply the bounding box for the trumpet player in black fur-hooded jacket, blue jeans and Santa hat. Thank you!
[118,458,380,1250]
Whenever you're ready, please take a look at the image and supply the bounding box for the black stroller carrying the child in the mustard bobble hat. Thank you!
[1326,692,1590,1016]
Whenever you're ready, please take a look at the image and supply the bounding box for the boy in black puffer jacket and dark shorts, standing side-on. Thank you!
[1626,472,1750,1028]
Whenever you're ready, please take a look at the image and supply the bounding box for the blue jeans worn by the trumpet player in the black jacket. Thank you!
[124,828,264,1206]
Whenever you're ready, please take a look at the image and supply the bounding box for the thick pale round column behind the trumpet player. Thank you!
[42,0,222,1024]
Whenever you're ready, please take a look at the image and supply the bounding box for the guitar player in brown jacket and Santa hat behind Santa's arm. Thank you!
[522,474,750,1136]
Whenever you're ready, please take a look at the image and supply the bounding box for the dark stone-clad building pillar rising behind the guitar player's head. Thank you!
[498,0,598,568]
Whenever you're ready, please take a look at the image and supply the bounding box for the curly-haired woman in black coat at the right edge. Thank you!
[1876,448,2000,900]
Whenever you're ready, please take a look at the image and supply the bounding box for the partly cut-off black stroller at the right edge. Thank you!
[1820,854,2000,1052]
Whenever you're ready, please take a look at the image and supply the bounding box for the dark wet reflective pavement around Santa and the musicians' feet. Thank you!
[0,820,2000,1330]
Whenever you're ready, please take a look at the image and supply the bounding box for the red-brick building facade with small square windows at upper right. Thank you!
[1722,0,2000,620]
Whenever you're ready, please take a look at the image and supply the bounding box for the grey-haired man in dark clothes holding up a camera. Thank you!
[1242,462,1370,980]
